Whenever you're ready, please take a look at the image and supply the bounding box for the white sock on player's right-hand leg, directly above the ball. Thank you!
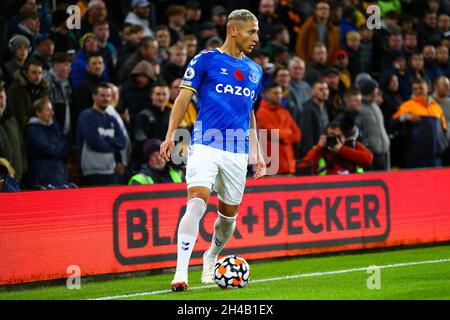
[206,211,237,260]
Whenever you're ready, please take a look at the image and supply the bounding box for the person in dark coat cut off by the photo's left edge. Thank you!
[0,82,27,182]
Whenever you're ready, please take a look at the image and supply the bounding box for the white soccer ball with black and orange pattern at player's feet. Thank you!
[214,255,250,289]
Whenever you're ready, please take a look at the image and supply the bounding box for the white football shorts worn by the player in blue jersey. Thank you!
[186,144,248,205]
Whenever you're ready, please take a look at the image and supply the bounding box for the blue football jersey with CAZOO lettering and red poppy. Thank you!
[180,49,262,153]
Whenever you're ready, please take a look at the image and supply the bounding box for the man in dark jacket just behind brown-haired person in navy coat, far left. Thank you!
[8,60,49,130]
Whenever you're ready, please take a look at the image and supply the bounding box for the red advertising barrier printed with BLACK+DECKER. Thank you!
[0,169,450,284]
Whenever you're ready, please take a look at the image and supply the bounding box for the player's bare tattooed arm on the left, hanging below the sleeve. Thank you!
[160,88,194,161]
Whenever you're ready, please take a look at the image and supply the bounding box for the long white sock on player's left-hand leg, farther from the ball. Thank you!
[176,198,206,274]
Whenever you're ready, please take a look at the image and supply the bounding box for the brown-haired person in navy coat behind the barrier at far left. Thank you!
[25,98,71,188]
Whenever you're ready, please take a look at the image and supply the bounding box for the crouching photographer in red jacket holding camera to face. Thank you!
[300,116,373,175]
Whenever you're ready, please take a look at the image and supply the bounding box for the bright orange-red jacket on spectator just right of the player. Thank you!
[256,99,301,174]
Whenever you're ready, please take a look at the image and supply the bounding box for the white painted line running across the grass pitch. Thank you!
[92,259,450,300]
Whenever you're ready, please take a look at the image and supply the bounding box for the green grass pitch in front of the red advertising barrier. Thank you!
[0,245,450,300]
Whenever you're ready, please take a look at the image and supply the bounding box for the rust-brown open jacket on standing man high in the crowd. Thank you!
[295,16,339,64]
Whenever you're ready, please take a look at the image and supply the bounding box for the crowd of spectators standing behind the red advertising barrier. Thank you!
[0,0,450,190]
